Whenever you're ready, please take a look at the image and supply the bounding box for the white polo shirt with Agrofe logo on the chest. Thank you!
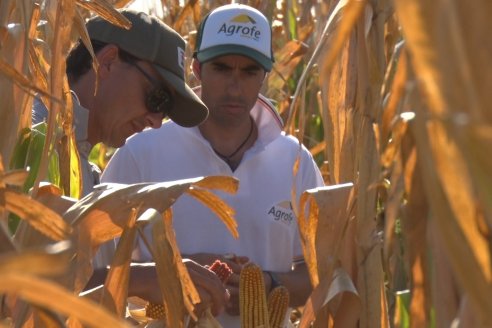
[102,96,323,327]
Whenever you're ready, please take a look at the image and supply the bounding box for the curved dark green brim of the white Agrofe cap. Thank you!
[196,44,272,72]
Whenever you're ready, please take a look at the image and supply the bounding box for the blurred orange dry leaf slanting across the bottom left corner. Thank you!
[0,272,129,327]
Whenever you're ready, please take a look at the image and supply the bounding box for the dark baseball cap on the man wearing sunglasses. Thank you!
[86,9,208,127]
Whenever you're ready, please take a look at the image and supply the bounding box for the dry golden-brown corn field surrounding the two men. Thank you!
[0,0,492,327]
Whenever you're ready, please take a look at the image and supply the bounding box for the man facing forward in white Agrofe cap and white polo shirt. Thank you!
[102,4,323,328]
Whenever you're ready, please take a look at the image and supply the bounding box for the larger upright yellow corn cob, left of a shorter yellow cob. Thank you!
[239,263,270,328]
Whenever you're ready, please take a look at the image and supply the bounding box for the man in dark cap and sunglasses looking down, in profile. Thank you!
[33,10,227,313]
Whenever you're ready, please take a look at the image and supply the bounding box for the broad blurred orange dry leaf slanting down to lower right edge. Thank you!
[414,113,492,319]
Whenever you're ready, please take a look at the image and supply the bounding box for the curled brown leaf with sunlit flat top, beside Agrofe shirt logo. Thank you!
[298,183,360,327]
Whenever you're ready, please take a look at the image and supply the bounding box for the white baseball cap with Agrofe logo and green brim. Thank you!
[194,3,274,71]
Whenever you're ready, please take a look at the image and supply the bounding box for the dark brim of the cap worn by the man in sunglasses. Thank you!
[154,65,208,127]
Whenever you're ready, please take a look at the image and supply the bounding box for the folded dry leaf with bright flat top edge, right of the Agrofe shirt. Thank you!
[300,183,360,327]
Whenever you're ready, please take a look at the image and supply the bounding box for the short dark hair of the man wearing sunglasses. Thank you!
[66,40,139,83]
